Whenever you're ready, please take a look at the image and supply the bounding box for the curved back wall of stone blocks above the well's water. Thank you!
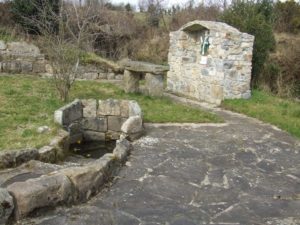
[54,99,143,143]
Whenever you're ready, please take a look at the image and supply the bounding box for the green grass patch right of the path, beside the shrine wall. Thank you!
[222,90,300,138]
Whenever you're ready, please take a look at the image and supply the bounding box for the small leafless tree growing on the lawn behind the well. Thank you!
[17,1,102,101]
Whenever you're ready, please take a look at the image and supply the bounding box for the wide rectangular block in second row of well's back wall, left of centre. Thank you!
[80,117,108,132]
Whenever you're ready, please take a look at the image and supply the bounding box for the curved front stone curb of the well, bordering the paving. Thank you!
[0,135,132,221]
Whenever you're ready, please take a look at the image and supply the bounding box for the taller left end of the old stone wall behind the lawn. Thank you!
[0,40,46,74]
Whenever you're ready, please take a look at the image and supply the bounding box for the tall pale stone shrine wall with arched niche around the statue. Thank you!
[167,21,254,104]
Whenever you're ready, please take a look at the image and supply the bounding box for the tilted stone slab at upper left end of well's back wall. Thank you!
[54,99,83,126]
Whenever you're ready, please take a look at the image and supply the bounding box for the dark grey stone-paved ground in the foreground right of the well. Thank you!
[19,104,300,225]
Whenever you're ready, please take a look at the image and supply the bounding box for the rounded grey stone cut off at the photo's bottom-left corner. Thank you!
[0,188,14,224]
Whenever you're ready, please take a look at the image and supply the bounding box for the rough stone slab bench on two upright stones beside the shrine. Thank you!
[124,61,169,96]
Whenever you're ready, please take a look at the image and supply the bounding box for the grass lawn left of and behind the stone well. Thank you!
[0,76,222,149]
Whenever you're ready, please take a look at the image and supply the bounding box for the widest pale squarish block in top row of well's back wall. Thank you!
[97,99,121,116]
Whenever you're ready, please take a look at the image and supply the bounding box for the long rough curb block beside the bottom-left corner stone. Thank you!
[7,174,72,219]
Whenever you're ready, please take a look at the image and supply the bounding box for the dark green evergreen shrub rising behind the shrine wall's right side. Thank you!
[221,0,275,86]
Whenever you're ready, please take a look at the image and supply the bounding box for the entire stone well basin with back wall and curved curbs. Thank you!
[0,99,144,224]
